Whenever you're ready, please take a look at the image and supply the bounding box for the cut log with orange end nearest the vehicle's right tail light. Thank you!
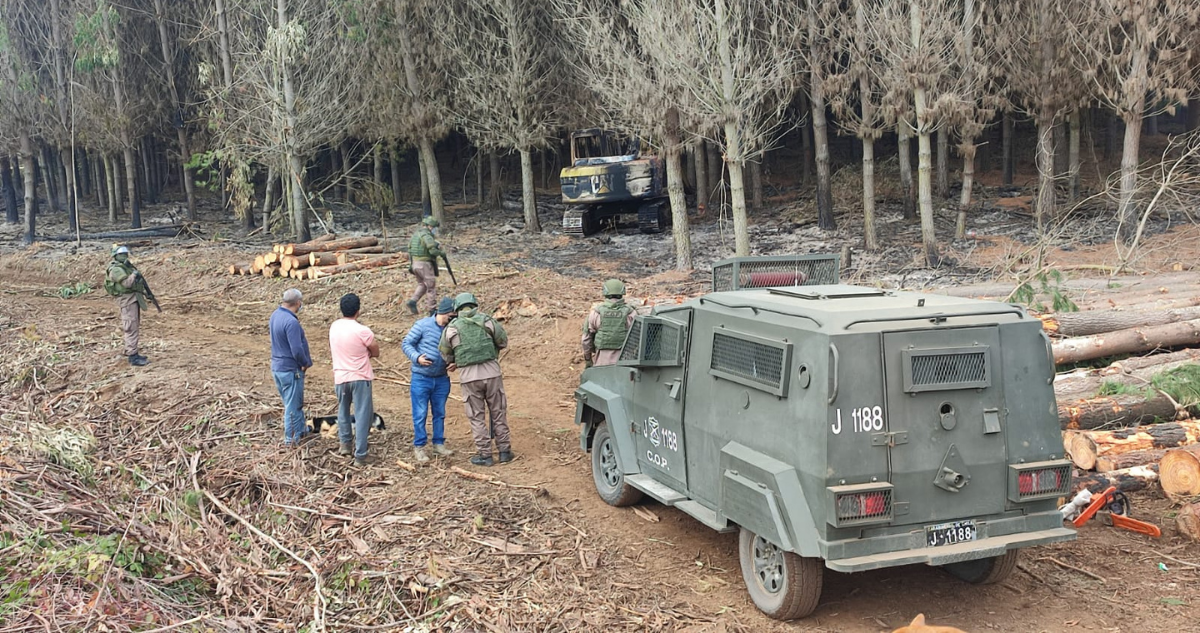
[1062,420,1200,470]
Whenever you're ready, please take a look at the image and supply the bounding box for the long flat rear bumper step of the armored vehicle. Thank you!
[826,528,1075,572]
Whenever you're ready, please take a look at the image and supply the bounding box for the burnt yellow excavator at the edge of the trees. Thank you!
[558,129,670,235]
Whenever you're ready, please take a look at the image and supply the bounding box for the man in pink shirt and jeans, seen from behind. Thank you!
[329,293,379,466]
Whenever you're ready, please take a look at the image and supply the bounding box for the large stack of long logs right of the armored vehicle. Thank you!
[947,272,1200,538]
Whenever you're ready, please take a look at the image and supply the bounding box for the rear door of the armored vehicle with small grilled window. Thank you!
[882,326,1008,524]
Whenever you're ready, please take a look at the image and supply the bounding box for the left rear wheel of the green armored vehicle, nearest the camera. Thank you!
[738,528,824,620]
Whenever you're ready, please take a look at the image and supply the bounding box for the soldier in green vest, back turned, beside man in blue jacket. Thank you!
[438,293,512,466]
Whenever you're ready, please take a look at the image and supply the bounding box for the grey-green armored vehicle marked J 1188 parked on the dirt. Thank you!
[575,255,1075,620]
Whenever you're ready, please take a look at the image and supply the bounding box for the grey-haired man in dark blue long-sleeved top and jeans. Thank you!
[268,288,312,446]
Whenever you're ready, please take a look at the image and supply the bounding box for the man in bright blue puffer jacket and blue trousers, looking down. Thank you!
[402,297,454,463]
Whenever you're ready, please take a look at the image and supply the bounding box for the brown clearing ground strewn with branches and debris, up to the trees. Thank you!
[0,169,1200,632]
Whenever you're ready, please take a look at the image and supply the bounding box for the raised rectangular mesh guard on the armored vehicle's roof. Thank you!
[713,255,840,293]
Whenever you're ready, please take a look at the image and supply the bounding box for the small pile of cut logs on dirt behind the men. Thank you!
[229,234,408,279]
